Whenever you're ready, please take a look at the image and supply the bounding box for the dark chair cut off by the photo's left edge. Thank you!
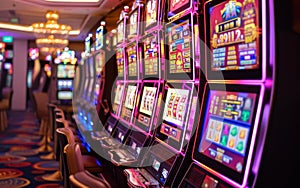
[0,87,14,131]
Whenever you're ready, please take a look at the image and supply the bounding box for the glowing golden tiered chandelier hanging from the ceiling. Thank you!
[32,11,71,54]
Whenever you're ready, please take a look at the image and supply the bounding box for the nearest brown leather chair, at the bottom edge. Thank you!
[65,143,111,188]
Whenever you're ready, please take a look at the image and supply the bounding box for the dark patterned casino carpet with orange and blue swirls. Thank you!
[0,111,63,188]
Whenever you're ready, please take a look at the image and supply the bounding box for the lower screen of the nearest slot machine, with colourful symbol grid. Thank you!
[198,90,257,173]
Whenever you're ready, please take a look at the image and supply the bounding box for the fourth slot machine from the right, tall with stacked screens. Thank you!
[96,3,143,154]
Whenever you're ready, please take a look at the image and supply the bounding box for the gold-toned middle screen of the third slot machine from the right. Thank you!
[143,35,159,78]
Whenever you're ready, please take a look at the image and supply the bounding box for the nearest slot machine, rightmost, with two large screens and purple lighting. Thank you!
[179,0,275,188]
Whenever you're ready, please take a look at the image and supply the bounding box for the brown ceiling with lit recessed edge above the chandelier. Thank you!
[0,0,132,41]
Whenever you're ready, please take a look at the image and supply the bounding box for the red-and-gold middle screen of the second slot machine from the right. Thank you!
[167,20,191,74]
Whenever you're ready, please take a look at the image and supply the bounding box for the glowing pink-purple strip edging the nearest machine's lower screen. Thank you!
[193,83,265,187]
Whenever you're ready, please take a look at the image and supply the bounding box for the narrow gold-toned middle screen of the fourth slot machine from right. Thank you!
[126,43,138,78]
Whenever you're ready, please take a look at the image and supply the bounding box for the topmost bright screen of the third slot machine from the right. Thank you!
[145,0,158,29]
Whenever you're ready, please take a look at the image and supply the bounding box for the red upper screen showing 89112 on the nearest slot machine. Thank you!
[207,0,260,71]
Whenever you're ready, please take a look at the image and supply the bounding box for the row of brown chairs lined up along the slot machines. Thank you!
[33,92,111,188]
